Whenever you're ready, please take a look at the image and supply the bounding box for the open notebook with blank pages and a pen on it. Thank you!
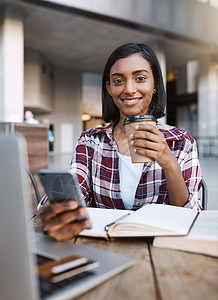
[80,204,199,239]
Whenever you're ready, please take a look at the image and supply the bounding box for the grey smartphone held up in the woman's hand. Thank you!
[38,169,88,221]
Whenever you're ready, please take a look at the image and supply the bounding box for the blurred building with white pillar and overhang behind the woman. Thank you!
[0,0,218,155]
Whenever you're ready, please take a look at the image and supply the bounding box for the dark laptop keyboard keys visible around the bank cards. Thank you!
[36,255,93,299]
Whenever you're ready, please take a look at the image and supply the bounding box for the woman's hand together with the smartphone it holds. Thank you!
[38,169,92,241]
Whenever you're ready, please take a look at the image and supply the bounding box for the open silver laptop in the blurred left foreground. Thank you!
[0,135,134,300]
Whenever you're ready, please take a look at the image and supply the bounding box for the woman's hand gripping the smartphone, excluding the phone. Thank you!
[41,200,92,241]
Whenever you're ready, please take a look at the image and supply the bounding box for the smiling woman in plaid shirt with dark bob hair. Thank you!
[42,43,202,240]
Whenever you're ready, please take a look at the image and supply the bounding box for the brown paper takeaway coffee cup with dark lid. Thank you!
[123,115,157,163]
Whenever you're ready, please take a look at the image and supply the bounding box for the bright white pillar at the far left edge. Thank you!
[0,5,24,122]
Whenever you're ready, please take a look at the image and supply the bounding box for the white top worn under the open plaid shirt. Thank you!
[118,152,144,209]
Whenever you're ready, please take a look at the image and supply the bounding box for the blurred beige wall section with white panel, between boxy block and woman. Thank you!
[40,69,82,155]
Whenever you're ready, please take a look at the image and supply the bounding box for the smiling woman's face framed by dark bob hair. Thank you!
[106,53,155,121]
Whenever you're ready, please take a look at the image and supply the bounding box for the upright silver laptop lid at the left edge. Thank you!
[0,135,38,299]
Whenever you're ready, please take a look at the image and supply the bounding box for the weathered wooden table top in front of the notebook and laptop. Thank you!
[34,220,218,300]
